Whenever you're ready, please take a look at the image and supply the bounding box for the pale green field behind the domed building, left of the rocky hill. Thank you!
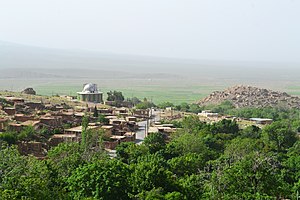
[0,79,225,104]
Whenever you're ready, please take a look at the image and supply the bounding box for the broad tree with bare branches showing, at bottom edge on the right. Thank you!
[209,152,283,199]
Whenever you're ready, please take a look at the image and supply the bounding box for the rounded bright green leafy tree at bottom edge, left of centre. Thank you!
[67,159,130,200]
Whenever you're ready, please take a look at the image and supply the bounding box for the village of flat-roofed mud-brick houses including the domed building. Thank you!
[0,83,272,159]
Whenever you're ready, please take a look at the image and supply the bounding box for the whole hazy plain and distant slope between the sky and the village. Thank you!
[0,42,300,104]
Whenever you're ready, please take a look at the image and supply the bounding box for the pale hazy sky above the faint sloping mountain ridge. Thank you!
[0,0,300,63]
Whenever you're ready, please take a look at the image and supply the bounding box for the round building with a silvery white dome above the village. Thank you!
[77,83,103,103]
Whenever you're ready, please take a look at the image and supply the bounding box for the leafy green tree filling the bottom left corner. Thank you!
[0,146,56,200]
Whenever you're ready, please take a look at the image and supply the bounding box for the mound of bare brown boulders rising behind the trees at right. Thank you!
[198,85,300,108]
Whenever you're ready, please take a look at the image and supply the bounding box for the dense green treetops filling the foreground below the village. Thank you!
[0,106,300,200]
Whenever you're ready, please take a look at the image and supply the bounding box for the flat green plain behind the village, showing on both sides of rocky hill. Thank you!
[0,79,300,104]
